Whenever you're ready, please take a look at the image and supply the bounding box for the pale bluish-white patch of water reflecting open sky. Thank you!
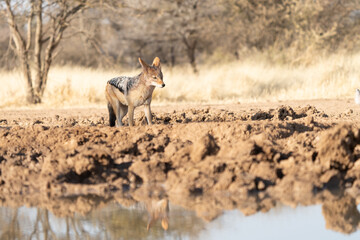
[199,205,360,240]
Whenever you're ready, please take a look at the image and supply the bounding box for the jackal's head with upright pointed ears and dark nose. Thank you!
[139,57,165,88]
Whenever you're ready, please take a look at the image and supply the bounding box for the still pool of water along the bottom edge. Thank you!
[0,200,360,240]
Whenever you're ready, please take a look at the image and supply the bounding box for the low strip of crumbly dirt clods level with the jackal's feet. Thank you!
[0,106,328,128]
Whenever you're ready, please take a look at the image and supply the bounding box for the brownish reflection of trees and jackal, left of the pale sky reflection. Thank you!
[0,200,204,239]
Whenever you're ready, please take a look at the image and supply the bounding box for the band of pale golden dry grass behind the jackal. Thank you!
[0,54,360,107]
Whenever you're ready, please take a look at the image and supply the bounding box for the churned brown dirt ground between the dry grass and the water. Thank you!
[0,99,360,233]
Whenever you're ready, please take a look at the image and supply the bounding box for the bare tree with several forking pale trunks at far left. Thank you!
[5,0,87,103]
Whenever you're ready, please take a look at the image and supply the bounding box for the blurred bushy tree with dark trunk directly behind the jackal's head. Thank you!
[101,0,224,73]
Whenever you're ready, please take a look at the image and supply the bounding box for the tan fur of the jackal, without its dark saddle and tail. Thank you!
[105,57,165,126]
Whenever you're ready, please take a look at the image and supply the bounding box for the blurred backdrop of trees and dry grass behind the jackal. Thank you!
[0,0,360,107]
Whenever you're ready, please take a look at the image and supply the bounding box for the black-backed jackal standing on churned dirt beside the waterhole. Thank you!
[105,57,165,126]
